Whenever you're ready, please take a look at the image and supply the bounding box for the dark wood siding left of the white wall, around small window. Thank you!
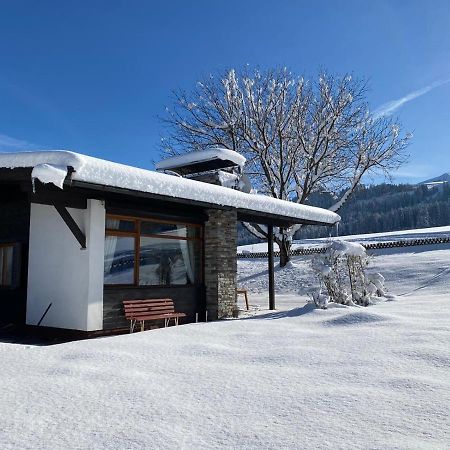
[0,184,30,325]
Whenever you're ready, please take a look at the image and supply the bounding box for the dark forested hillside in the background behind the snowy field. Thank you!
[238,183,450,245]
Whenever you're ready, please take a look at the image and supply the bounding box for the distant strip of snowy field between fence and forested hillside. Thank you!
[238,225,450,253]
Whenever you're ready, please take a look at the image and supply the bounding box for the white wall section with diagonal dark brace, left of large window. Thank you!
[27,200,105,331]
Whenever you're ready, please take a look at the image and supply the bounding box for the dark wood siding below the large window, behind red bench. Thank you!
[103,286,204,330]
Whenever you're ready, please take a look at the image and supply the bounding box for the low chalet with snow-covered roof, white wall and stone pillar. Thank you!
[0,151,339,333]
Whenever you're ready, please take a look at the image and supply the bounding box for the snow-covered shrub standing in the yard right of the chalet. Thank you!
[312,240,385,308]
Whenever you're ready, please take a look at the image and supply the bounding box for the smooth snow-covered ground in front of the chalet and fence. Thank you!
[0,246,450,449]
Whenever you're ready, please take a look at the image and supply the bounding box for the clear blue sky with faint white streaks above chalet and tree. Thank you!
[0,0,450,182]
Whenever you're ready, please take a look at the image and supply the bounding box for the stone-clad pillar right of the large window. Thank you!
[204,209,237,320]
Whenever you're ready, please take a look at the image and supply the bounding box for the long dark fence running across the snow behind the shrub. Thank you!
[237,236,450,259]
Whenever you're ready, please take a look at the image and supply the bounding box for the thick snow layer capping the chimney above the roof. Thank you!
[155,148,246,170]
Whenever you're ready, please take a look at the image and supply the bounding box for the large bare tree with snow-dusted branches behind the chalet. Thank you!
[162,69,410,266]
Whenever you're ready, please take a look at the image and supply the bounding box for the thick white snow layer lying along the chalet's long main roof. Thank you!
[0,150,340,224]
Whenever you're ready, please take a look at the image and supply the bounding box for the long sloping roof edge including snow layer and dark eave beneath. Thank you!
[0,151,340,227]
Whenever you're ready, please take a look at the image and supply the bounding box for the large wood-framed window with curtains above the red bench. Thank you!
[105,215,202,286]
